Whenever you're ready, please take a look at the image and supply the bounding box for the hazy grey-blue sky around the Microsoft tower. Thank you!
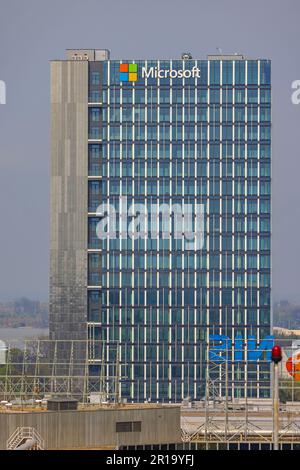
[0,0,300,300]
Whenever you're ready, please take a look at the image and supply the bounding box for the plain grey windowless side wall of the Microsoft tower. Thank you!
[50,61,88,340]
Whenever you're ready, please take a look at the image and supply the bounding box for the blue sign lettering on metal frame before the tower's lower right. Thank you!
[208,335,274,362]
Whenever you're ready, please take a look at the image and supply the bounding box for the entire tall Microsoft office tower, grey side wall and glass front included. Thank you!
[50,50,271,401]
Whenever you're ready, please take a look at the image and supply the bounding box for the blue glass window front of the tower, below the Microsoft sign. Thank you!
[87,60,271,401]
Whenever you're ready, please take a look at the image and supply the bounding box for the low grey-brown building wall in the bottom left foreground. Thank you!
[0,407,181,449]
